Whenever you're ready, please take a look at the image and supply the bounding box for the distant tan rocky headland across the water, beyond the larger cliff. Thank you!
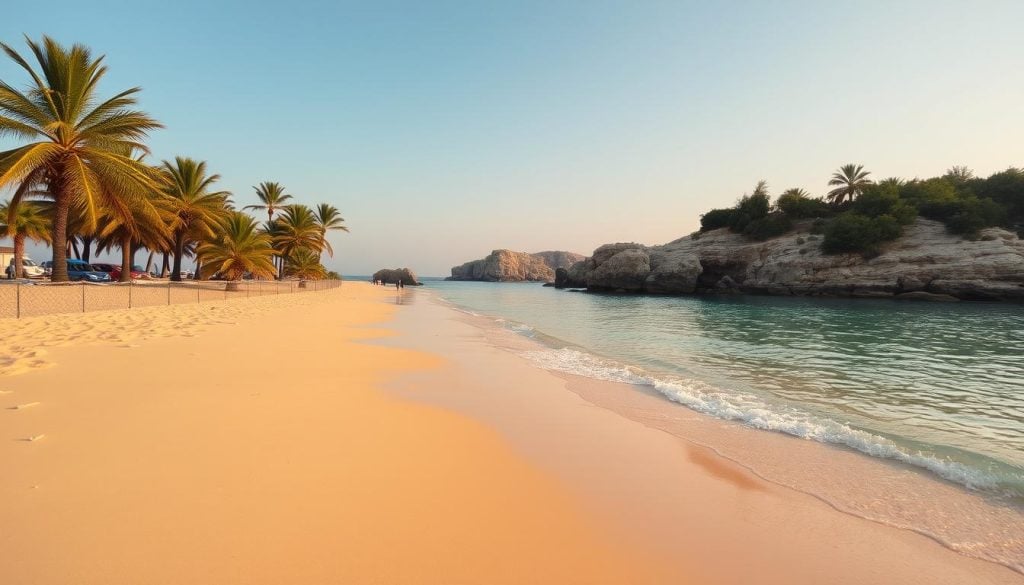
[447,250,584,283]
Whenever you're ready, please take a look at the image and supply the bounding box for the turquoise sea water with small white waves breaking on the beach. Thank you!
[427,281,1024,503]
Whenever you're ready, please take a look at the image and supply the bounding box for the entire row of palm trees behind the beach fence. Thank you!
[0,37,348,282]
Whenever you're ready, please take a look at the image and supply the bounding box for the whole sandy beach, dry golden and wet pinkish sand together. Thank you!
[0,283,1024,585]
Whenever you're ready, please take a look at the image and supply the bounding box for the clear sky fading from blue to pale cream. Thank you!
[0,0,1024,276]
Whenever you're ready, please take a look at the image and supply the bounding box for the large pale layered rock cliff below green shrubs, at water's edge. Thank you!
[556,219,1024,300]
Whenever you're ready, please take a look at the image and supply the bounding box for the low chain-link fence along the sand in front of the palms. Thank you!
[0,281,341,319]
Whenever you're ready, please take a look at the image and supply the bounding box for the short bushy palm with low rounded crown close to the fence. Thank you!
[196,211,274,290]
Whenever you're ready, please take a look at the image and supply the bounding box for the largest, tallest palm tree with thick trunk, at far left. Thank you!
[0,36,161,282]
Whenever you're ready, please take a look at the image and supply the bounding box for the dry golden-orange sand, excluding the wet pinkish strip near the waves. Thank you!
[0,284,678,585]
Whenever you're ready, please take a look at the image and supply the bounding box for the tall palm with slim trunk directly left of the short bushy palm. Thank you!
[163,157,230,282]
